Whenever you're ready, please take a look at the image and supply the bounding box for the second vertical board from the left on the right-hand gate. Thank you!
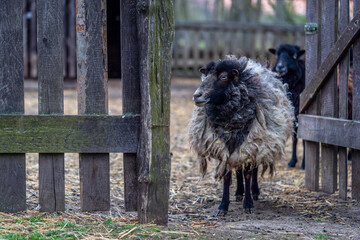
[320,0,338,193]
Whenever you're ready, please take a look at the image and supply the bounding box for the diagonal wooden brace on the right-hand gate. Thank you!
[300,11,360,113]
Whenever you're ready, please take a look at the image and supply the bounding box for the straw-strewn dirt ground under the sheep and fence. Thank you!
[0,79,360,239]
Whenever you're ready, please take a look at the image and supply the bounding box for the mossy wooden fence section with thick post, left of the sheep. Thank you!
[0,0,174,224]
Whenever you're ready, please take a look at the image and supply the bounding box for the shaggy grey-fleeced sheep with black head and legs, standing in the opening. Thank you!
[189,57,294,215]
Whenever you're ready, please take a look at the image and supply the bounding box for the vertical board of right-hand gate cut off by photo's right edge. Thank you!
[351,1,360,200]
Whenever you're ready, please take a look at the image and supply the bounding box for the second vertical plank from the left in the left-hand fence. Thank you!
[37,0,65,212]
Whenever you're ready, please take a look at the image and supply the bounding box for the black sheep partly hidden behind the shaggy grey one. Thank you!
[269,44,305,169]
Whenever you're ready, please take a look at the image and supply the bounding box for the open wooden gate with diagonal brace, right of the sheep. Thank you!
[298,0,360,200]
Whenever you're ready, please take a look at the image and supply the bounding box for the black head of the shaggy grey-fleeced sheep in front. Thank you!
[193,58,247,106]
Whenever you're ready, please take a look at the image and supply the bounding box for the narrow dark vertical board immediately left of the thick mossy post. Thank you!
[120,0,141,211]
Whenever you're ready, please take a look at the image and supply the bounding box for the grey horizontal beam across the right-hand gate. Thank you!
[298,114,360,149]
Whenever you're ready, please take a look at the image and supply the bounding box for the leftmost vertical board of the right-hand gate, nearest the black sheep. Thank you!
[300,0,320,191]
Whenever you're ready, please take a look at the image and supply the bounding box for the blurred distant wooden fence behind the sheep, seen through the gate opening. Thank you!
[173,22,305,77]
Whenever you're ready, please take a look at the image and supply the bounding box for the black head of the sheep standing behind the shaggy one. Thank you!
[269,44,305,76]
